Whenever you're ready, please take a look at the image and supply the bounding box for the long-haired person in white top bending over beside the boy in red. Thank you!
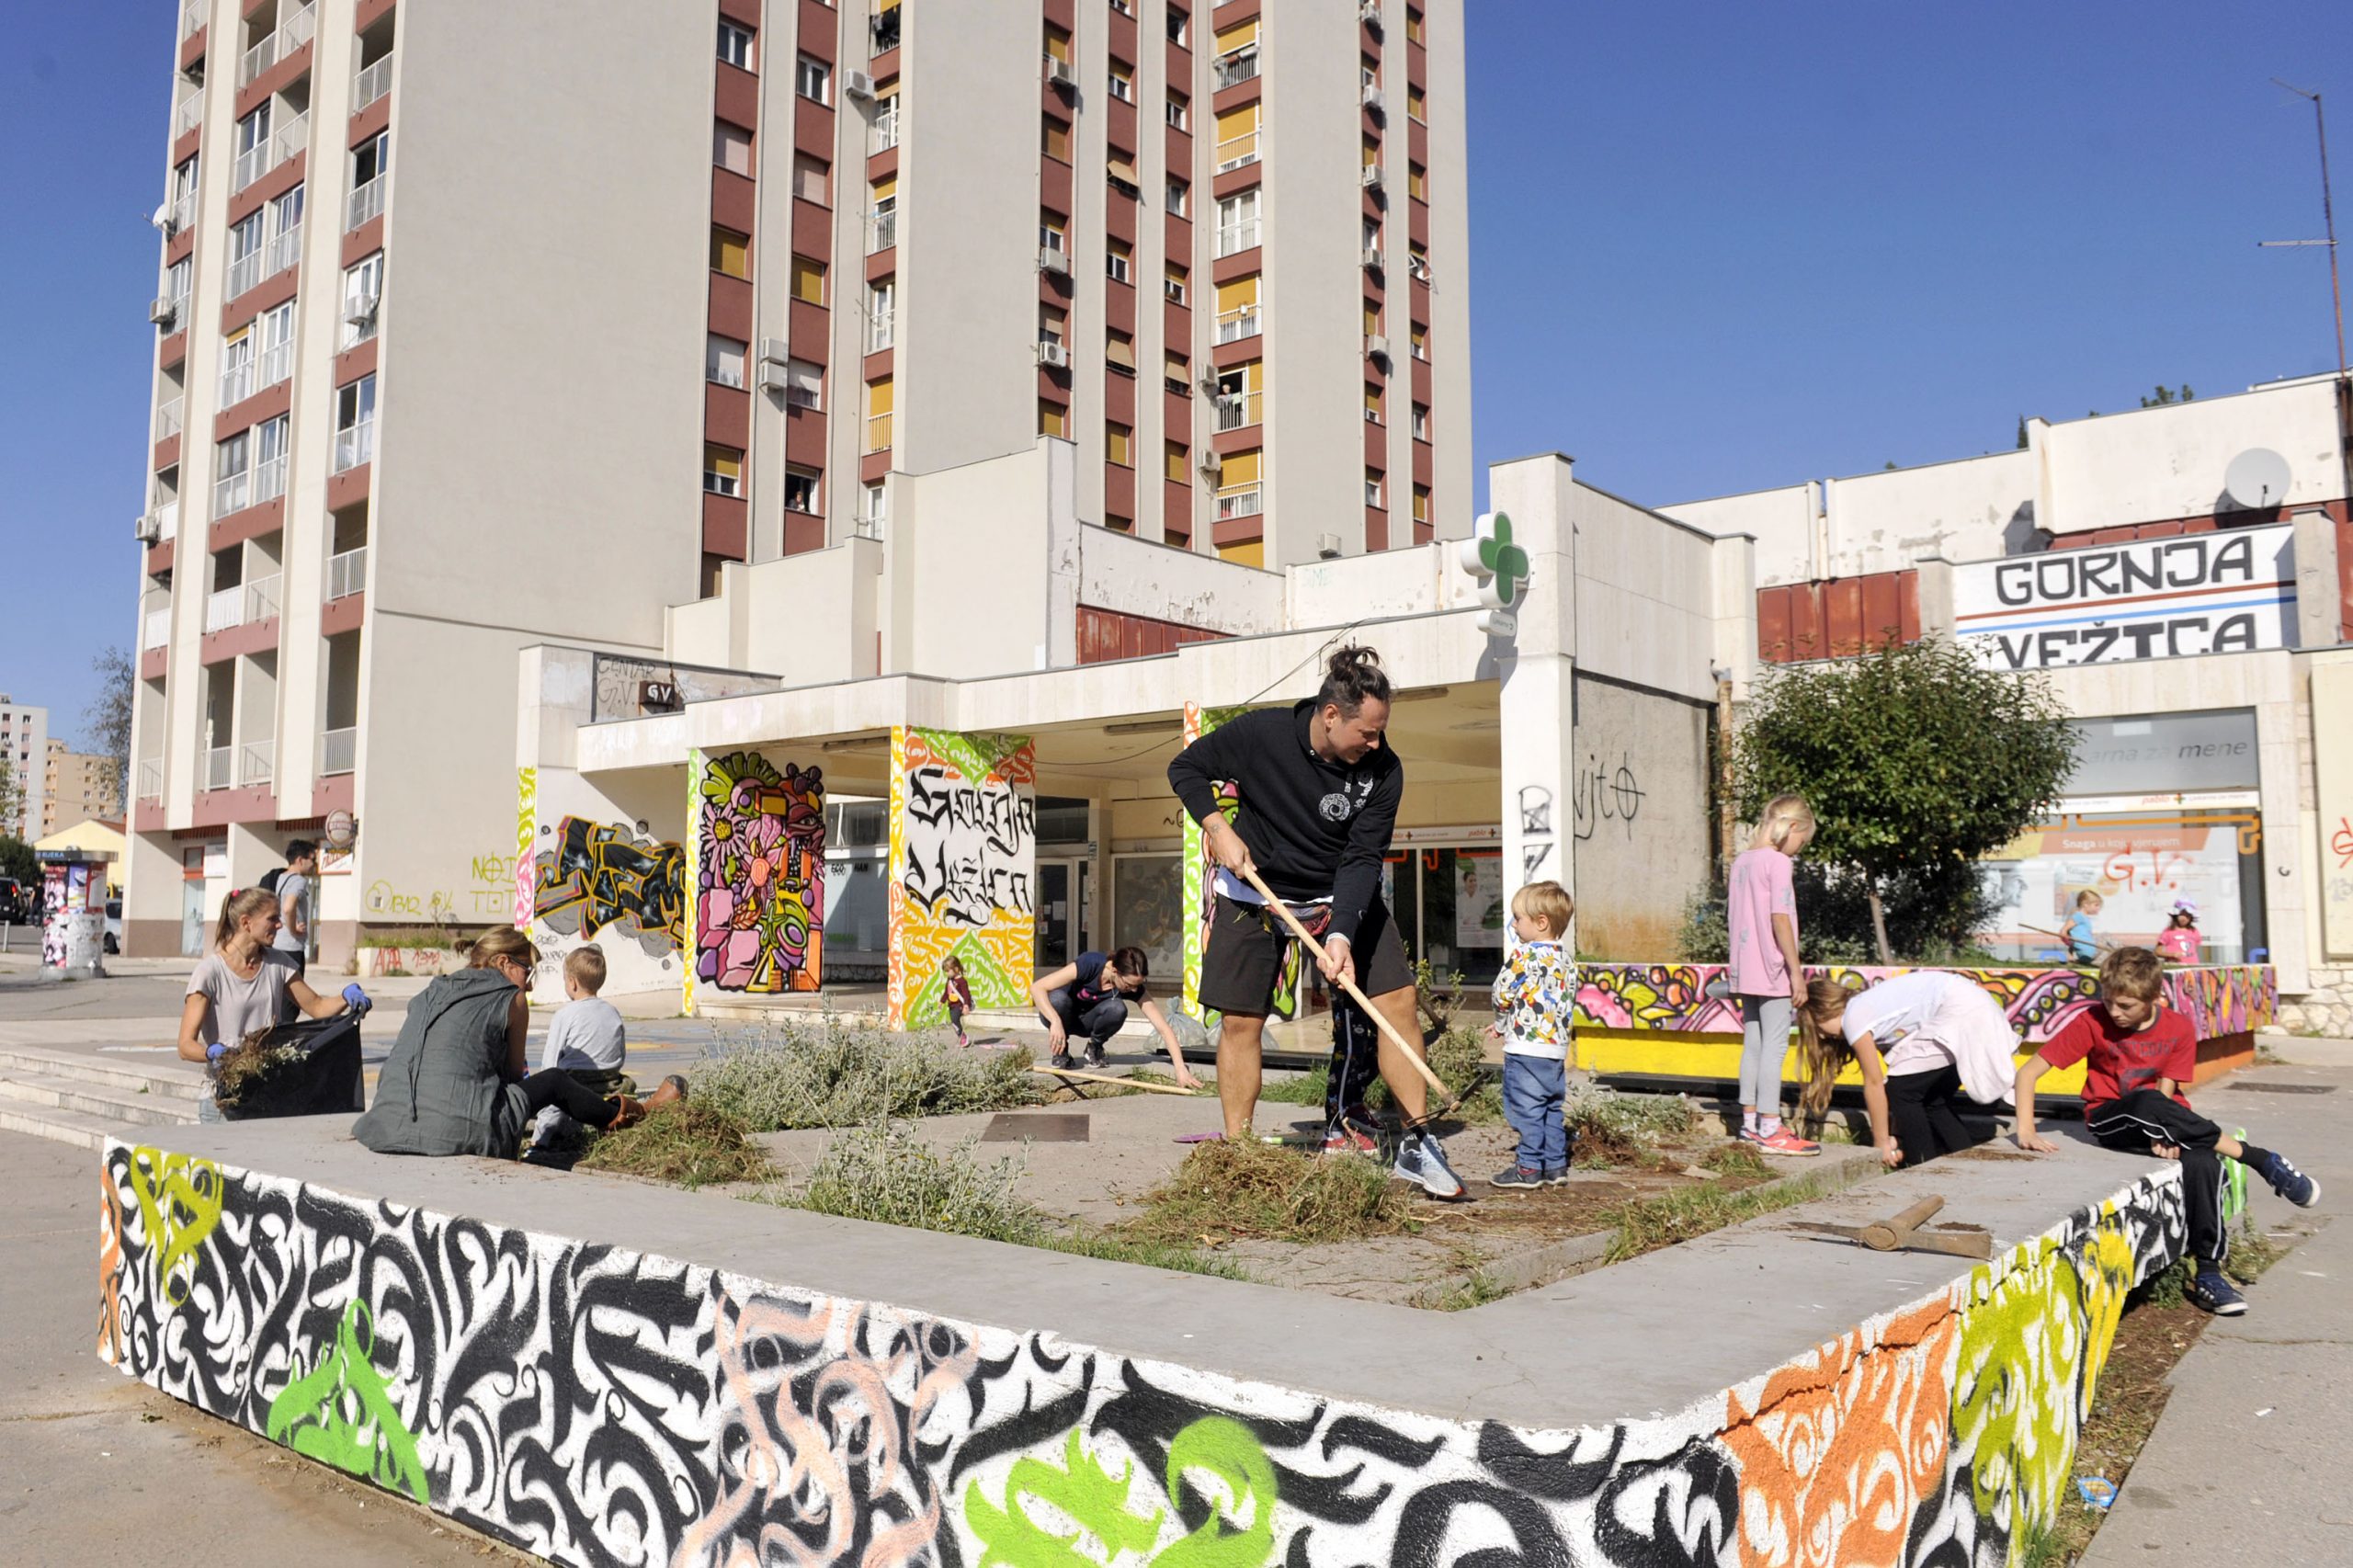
[1798,970,2018,1165]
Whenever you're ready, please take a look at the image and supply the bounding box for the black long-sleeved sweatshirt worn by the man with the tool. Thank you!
[1169,701,1404,942]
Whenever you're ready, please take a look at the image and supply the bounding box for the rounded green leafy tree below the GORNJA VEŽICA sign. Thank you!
[1732,641,2075,963]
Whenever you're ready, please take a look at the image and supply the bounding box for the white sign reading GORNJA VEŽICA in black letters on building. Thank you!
[1953,523,2297,668]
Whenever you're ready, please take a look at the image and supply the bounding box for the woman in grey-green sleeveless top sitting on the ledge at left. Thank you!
[350,926,680,1158]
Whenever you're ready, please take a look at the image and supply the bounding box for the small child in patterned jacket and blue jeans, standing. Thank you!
[1487,883,1576,1189]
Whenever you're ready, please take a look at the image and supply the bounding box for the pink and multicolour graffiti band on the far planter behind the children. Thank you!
[1576,963,2278,1043]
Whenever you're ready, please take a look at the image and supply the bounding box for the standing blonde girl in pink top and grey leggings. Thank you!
[1724,796,1821,1153]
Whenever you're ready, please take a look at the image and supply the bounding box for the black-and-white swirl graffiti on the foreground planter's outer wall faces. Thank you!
[97,1142,2184,1568]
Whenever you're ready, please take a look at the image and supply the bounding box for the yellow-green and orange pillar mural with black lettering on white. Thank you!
[887,728,1038,1028]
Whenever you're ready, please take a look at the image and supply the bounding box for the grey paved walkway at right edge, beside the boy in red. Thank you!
[2083,1036,2353,1568]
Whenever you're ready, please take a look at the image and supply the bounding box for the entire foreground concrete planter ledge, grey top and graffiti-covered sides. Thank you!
[97,1119,2181,1568]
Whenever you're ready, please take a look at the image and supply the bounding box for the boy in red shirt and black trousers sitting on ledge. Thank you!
[2014,947,2320,1318]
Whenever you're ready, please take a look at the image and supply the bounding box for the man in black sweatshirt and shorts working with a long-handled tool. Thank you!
[1169,645,1463,1199]
